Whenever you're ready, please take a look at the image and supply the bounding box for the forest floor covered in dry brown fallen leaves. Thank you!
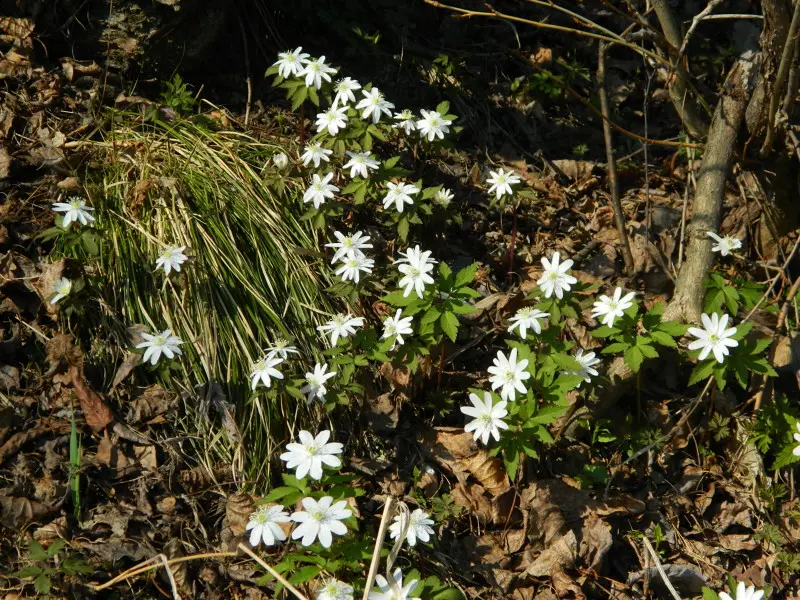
[0,1,800,600]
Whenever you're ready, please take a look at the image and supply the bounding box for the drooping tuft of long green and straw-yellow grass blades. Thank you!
[88,118,334,481]
